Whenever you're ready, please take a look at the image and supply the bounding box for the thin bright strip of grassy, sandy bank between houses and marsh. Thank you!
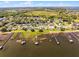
[0,30,79,34]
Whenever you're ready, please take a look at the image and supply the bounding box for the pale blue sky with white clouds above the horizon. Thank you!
[0,1,79,7]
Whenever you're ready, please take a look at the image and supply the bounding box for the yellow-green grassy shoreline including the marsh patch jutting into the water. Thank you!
[0,30,79,42]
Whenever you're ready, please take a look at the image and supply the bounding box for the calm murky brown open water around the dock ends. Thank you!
[0,34,79,57]
